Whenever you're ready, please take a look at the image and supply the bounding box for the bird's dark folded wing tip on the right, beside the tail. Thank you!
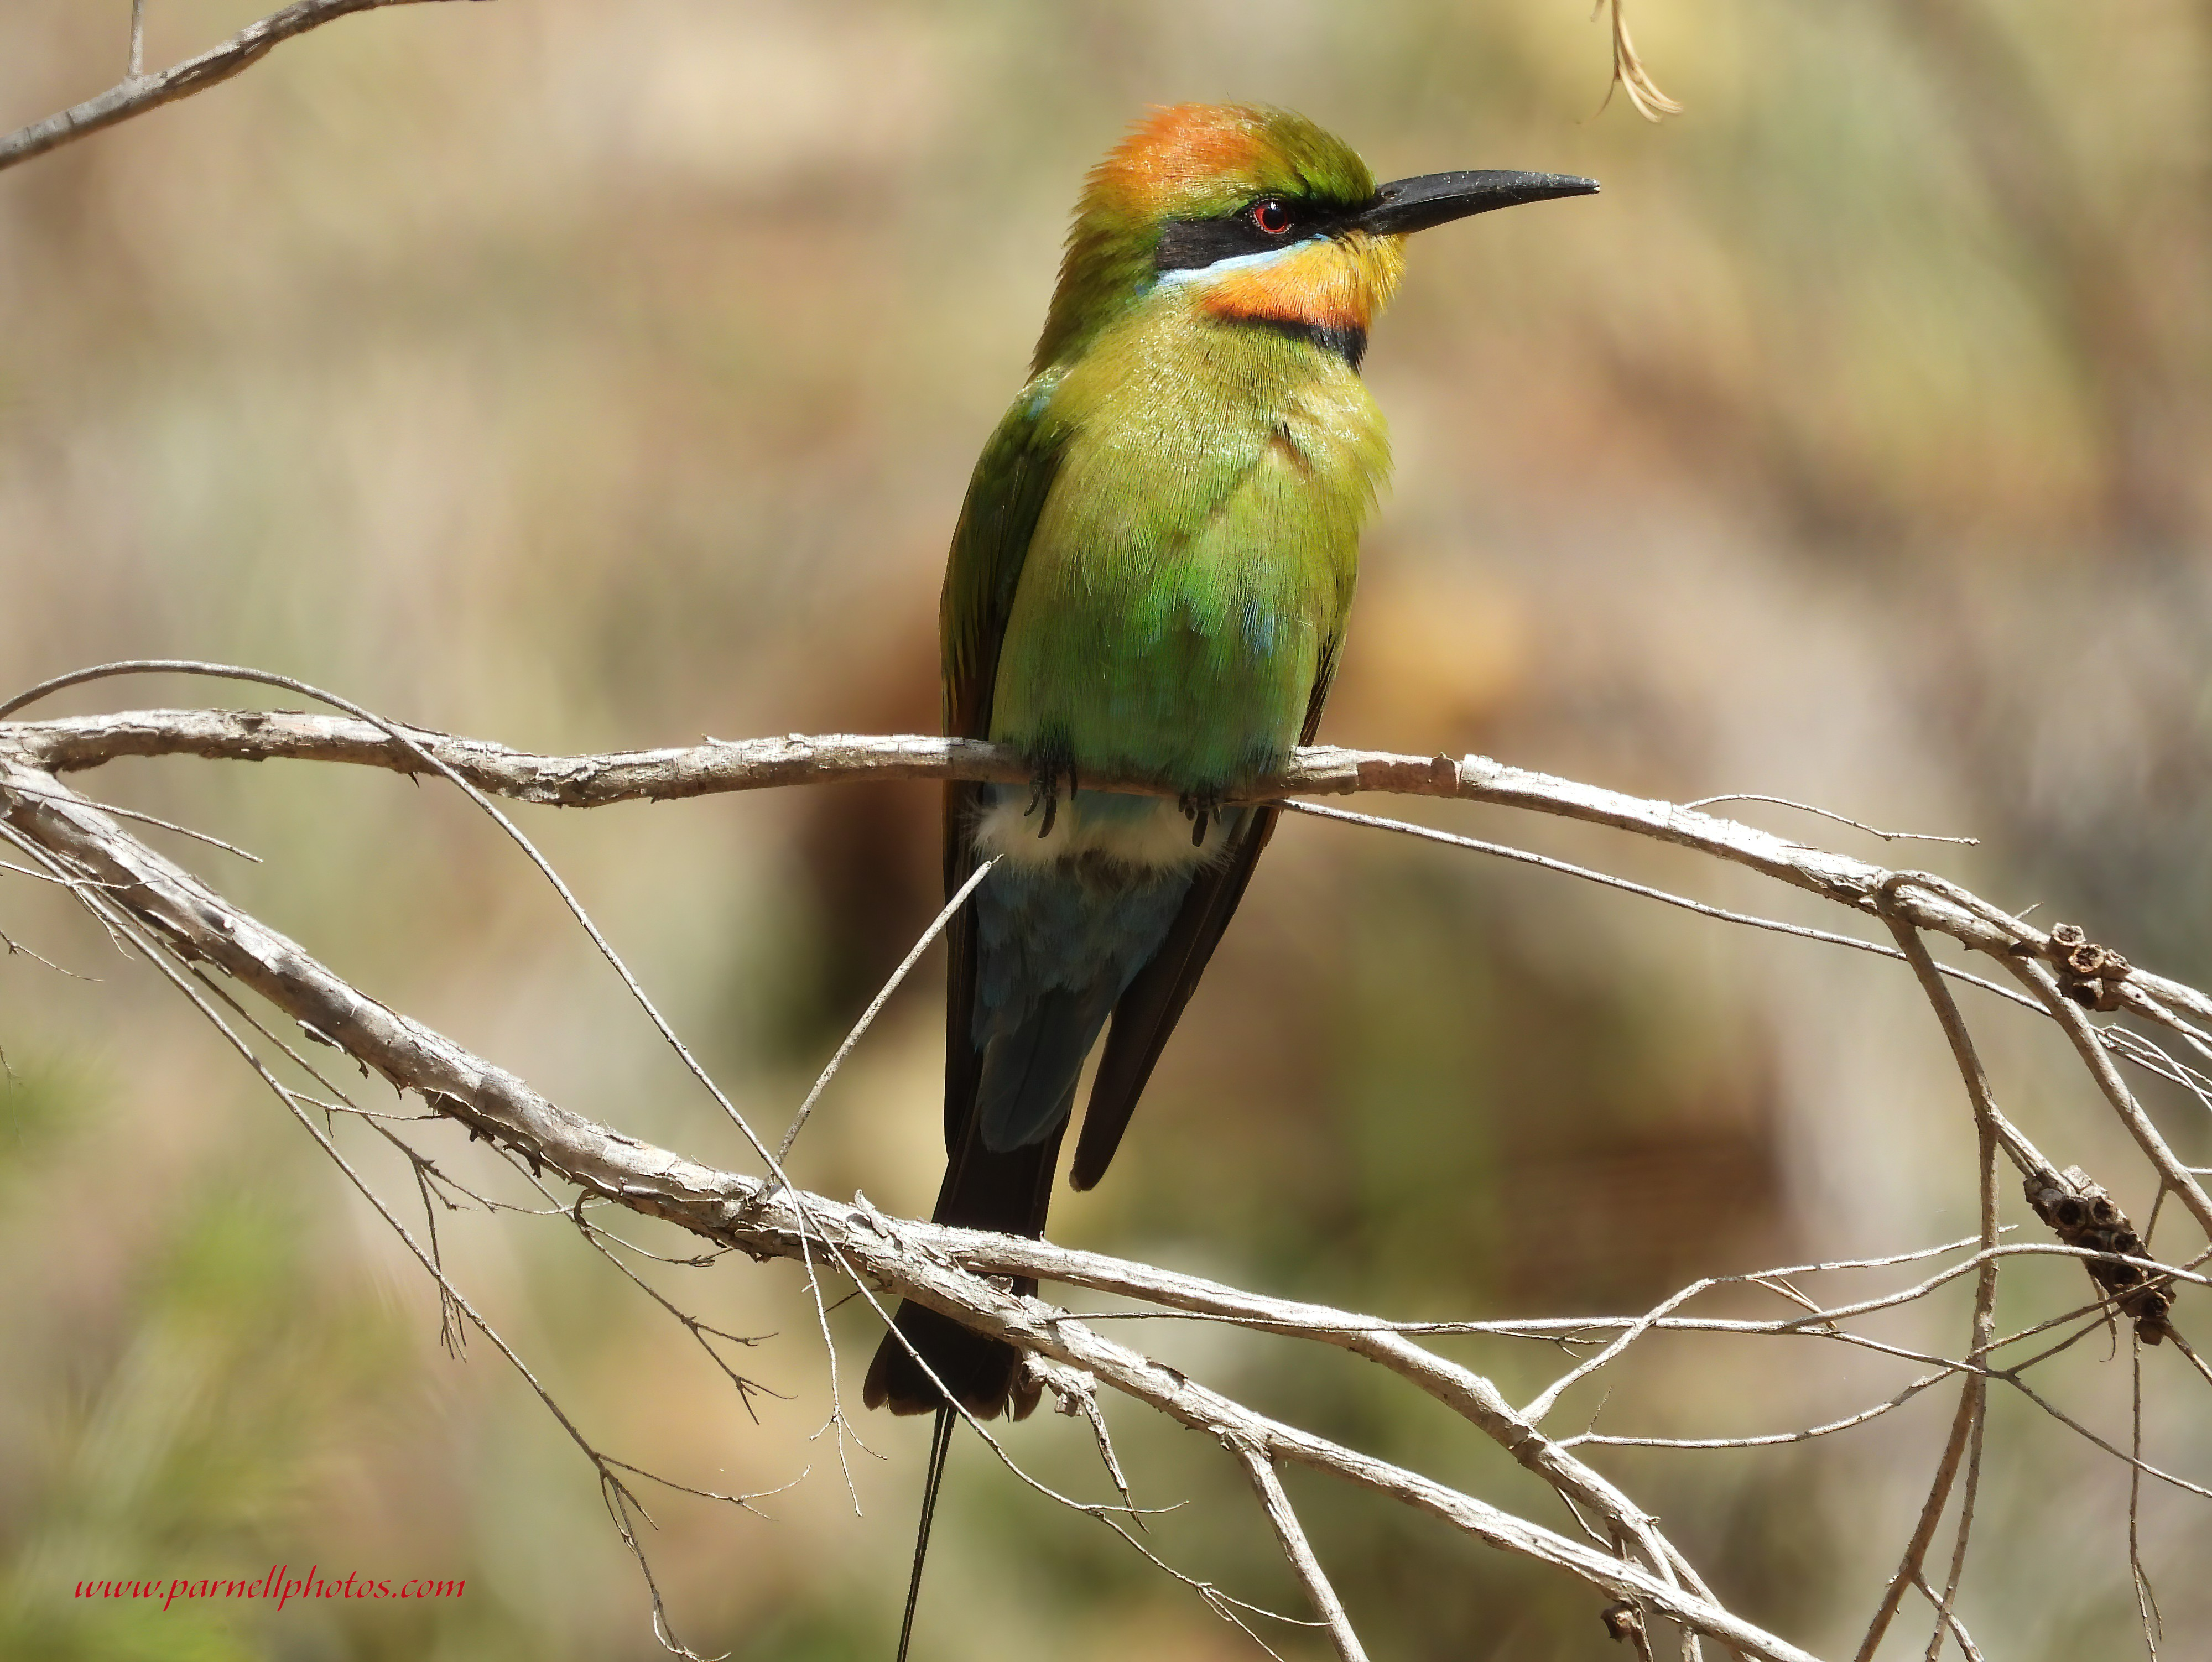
[1069,633,1342,1189]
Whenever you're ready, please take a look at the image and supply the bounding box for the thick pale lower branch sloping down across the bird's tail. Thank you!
[0,763,1807,1662]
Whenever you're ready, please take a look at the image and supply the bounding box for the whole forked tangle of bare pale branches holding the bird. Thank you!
[0,695,2212,1658]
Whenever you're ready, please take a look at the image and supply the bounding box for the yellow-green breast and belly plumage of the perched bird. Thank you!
[982,285,1389,792]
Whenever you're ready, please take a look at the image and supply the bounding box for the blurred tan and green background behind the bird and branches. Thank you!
[0,0,2212,1662]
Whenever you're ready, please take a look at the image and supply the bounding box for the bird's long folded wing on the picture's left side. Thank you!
[938,369,1064,1164]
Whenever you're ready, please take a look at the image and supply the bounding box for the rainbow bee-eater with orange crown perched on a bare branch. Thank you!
[867,104,1597,1434]
